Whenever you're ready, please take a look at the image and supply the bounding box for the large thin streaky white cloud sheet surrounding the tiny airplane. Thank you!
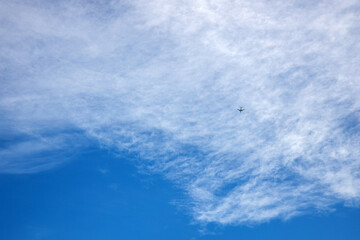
[0,0,360,224]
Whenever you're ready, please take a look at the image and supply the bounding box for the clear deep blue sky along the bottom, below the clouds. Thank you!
[0,143,360,240]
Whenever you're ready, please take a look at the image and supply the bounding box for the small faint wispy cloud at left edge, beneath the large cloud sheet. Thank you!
[0,132,87,174]
